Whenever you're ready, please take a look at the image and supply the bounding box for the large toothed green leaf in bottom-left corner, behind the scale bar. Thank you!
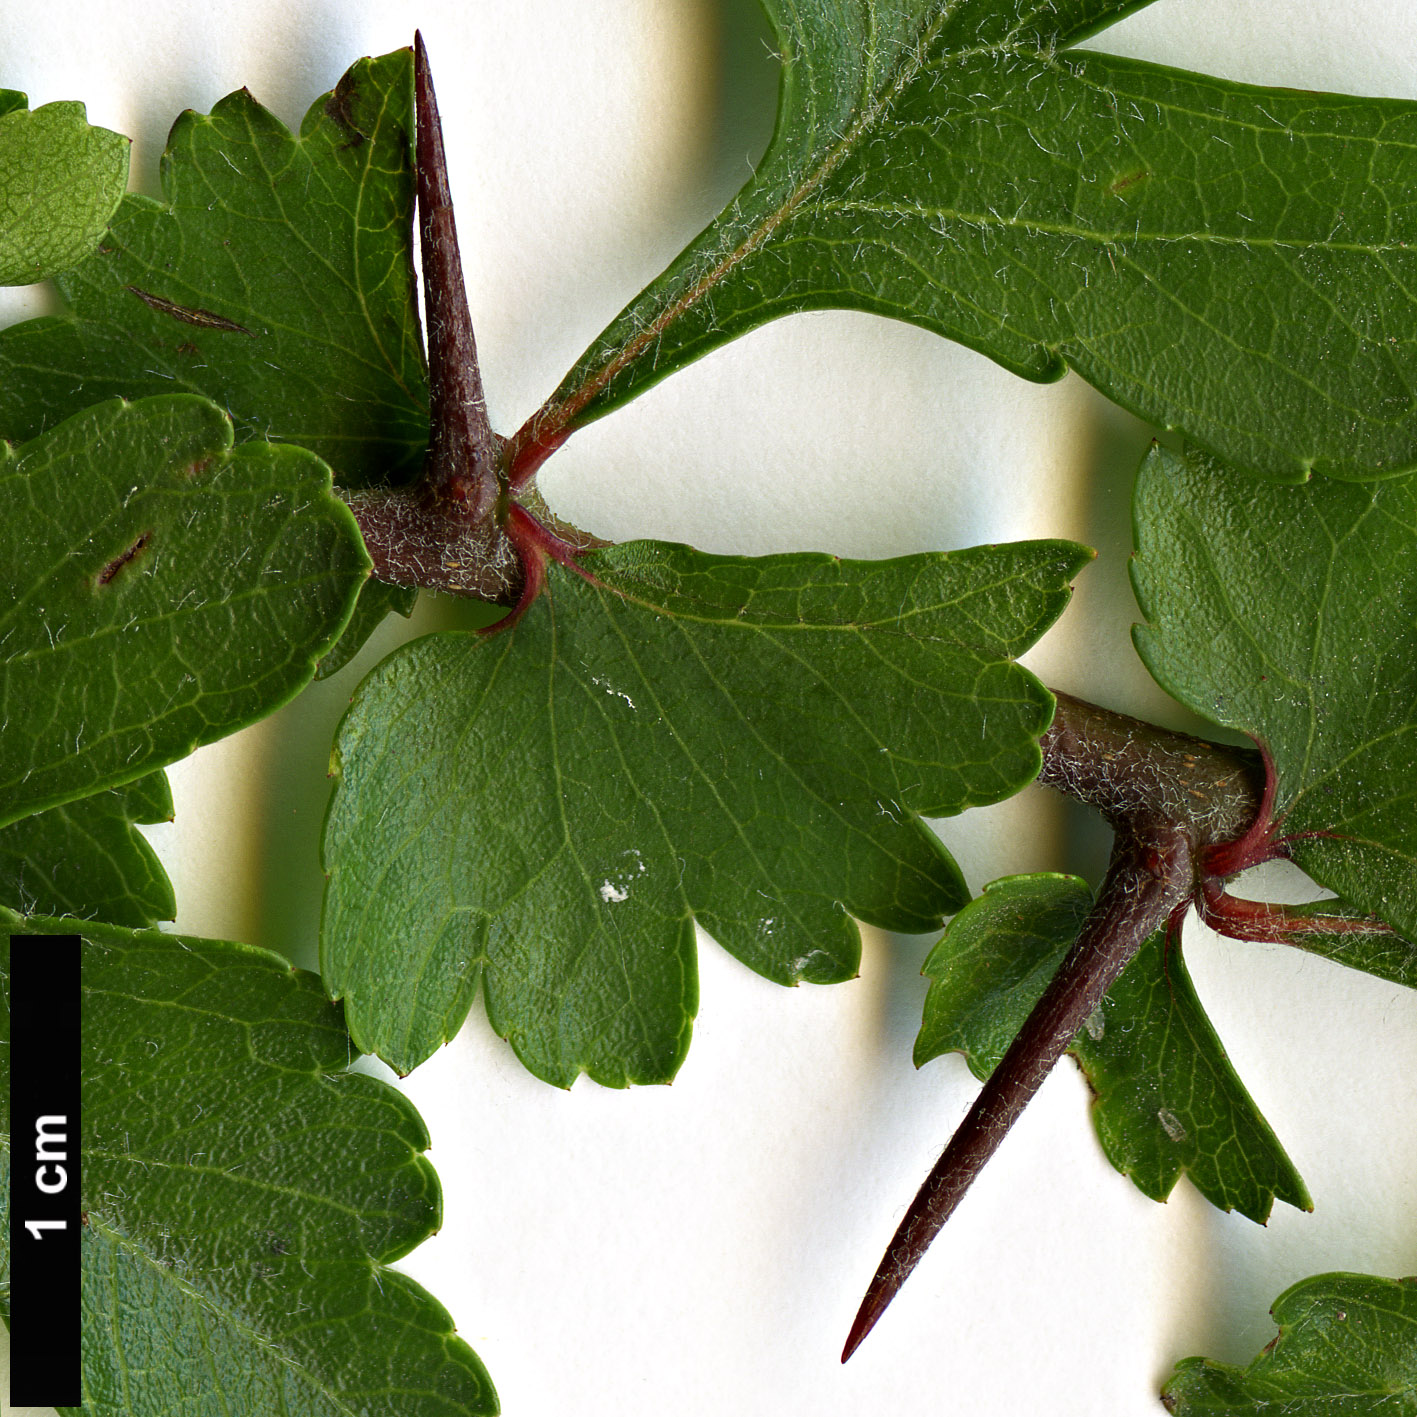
[0,915,497,1417]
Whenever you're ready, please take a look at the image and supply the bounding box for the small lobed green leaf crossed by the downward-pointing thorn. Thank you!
[915,876,1312,1223]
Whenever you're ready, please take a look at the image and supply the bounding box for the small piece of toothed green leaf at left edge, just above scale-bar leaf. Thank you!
[0,772,177,927]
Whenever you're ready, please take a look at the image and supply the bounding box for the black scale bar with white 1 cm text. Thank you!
[10,935,84,1407]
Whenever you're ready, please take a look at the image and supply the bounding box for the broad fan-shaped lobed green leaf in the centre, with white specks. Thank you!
[320,541,1090,1085]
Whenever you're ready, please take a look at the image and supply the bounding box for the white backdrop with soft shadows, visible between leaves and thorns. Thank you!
[0,0,1417,1417]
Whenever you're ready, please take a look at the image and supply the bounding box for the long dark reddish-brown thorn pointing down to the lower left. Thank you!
[842,833,1190,1363]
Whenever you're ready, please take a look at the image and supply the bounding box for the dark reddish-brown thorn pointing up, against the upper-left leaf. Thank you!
[414,34,499,521]
